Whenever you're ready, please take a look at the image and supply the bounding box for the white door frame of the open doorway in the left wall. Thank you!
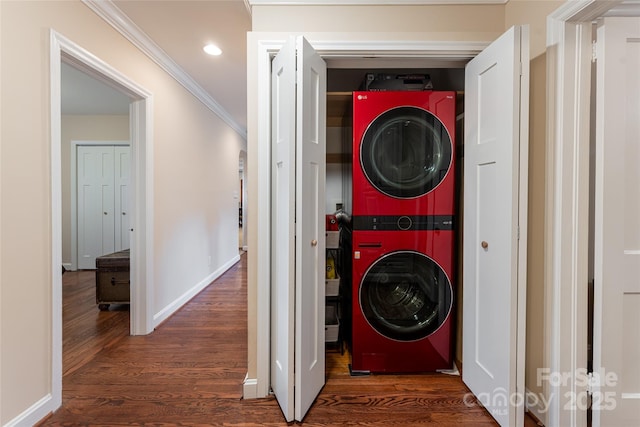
[45,30,153,412]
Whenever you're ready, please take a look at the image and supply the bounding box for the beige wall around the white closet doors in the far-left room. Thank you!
[61,115,129,264]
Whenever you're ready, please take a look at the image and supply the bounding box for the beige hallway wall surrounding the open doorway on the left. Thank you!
[0,0,246,425]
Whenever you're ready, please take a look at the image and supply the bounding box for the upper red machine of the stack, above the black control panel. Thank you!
[352,91,456,216]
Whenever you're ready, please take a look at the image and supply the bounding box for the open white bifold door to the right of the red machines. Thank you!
[462,27,529,426]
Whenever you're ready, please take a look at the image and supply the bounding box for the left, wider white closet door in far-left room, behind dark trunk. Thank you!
[76,146,115,269]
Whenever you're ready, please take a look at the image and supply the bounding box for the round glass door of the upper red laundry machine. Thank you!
[360,107,452,199]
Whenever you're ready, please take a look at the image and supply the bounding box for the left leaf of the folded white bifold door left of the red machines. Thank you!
[271,39,296,422]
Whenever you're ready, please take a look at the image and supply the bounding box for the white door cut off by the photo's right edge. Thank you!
[591,17,640,427]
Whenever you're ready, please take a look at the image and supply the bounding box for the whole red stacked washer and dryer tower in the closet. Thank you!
[351,91,456,373]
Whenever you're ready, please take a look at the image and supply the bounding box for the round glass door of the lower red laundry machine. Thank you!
[360,251,453,341]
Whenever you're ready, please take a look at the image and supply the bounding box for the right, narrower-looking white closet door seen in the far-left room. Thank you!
[113,146,131,251]
